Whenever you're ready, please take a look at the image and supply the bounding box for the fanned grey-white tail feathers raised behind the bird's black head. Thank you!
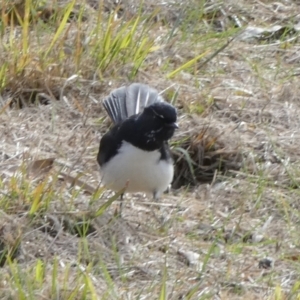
[103,83,164,124]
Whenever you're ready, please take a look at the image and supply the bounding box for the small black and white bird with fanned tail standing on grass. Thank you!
[97,83,178,199]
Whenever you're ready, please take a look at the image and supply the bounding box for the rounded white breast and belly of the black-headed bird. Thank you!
[101,142,174,197]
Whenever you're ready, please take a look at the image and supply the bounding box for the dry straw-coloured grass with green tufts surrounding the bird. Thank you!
[0,0,300,299]
